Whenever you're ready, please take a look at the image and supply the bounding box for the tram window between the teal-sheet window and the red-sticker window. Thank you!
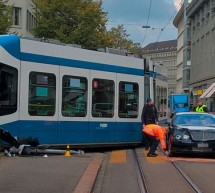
[62,76,87,117]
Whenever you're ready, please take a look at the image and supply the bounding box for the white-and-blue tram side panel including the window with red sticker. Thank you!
[89,70,117,143]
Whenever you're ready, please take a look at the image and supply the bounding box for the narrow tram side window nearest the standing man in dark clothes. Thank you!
[119,82,139,118]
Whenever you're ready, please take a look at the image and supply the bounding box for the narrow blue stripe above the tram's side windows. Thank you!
[21,52,144,76]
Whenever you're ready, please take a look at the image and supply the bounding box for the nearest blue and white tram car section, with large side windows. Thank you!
[0,35,148,146]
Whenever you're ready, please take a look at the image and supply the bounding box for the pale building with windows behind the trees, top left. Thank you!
[7,0,36,37]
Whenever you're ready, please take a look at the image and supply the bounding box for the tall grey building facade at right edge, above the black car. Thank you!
[186,0,215,111]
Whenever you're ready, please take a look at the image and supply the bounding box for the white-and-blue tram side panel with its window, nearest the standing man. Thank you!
[116,74,144,143]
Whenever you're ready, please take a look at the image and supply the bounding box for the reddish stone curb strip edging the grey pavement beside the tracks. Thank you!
[73,154,103,193]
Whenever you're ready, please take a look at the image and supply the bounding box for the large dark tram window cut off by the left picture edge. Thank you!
[0,63,18,116]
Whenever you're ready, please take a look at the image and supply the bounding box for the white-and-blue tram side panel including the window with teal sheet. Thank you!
[19,61,59,144]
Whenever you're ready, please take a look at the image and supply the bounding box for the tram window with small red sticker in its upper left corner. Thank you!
[92,79,115,118]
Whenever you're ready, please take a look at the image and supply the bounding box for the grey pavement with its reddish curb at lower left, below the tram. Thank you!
[0,153,103,193]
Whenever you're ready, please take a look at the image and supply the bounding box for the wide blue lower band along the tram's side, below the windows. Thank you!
[1,120,142,144]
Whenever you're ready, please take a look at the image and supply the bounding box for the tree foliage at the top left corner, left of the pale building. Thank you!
[0,0,12,34]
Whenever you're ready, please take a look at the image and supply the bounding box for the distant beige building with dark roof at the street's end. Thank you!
[143,40,177,95]
